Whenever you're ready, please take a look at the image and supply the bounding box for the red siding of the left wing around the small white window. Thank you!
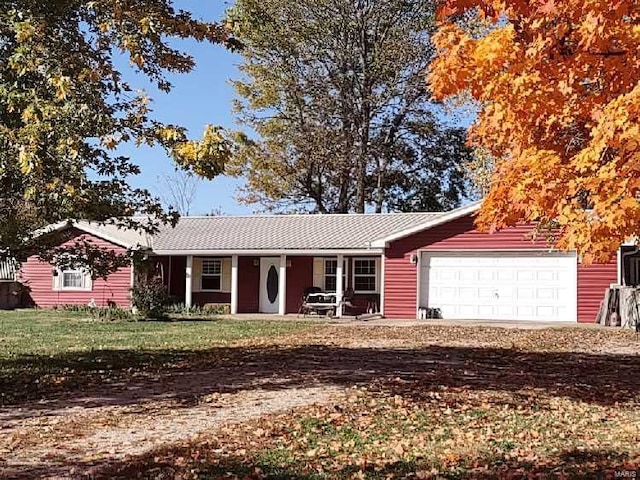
[20,231,131,308]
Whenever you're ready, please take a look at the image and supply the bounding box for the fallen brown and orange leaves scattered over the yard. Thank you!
[1,325,640,479]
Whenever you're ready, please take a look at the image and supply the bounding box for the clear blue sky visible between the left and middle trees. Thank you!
[123,0,254,215]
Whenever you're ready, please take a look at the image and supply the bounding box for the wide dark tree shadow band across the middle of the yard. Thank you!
[0,345,640,412]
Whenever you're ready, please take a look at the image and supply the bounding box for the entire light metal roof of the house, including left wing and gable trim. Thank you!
[41,202,480,254]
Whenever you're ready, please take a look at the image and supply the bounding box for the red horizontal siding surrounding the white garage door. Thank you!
[384,215,617,323]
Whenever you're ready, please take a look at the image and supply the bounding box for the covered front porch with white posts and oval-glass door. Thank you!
[155,253,384,317]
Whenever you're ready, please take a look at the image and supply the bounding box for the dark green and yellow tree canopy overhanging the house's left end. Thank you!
[0,0,234,266]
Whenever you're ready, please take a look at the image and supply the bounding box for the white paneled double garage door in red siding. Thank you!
[419,252,577,322]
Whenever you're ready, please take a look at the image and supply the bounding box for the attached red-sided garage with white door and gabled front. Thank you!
[380,204,619,323]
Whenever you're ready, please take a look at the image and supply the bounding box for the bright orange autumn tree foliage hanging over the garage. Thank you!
[428,0,640,262]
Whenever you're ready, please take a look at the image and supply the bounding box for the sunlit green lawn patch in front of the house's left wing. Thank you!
[0,310,310,404]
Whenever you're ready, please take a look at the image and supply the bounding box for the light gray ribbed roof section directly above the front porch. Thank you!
[153,213,442,251]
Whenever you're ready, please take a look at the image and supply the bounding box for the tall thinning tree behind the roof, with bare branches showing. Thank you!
[228,0,470,213]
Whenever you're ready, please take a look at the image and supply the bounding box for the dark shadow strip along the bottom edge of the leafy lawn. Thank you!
[0,447,640,480]
